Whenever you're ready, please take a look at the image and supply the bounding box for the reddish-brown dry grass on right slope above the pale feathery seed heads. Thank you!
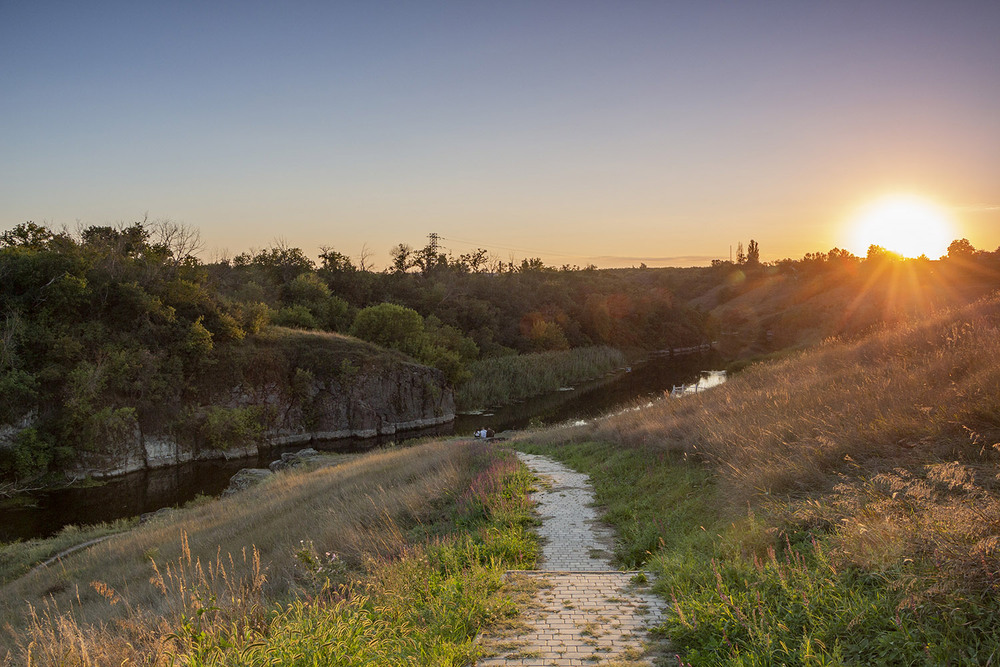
[576,297,1000,502]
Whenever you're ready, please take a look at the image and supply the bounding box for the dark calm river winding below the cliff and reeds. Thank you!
[0,353,718,541]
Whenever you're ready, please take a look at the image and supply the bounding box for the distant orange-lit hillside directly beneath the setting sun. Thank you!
[690,253,1000,357]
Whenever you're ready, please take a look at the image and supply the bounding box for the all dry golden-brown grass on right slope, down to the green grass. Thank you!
[531,296,1000,591]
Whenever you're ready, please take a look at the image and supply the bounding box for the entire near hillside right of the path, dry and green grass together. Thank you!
[524,296,1000,665]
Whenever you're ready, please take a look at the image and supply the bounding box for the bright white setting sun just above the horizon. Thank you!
[850,195,956,259]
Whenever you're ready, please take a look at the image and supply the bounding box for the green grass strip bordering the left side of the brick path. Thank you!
[169,452,537,666]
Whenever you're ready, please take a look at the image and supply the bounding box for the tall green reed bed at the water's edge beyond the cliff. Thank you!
[455,346,626,410]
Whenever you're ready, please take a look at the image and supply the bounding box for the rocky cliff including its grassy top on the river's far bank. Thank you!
[68,333,455,477]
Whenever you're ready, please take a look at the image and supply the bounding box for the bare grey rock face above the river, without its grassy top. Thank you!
[68,357,455,478]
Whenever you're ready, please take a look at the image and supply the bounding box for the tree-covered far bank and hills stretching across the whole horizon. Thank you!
[0,222,1000,477]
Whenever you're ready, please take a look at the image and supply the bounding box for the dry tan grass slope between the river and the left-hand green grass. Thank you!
[0,443,471,665]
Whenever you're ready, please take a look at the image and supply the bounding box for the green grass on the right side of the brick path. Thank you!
[518,442,1000,666]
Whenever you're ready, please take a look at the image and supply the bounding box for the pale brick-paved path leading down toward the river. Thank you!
[477,452,665,667]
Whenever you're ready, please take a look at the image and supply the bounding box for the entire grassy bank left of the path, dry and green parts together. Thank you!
[0,441,537,666]
